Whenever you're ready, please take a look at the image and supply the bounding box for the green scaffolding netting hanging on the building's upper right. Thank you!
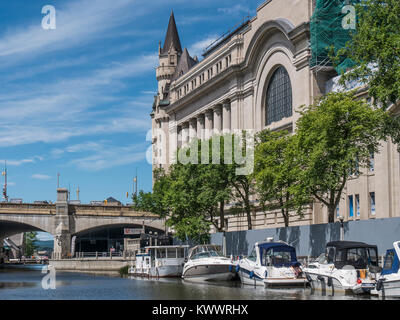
[310,0,360,74]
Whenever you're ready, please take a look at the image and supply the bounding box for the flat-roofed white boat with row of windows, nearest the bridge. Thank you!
[129,245,189,278]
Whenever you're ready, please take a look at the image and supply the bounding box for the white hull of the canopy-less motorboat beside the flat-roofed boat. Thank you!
[182,264,236,282]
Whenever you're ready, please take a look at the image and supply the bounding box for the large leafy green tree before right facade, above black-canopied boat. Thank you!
[294,92,387,222]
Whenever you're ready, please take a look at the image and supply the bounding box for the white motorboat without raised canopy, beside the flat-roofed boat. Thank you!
[182,244,236,282]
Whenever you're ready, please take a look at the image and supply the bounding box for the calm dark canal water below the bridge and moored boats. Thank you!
[0,265,396,300]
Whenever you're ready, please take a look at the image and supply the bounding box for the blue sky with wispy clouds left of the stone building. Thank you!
[0,0,263,203]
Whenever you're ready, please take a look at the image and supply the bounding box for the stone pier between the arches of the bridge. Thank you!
[53,189,71,259]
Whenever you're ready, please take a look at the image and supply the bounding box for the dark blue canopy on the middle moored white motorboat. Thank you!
[258,242,300,267]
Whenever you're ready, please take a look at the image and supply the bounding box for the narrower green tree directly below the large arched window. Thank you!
[254,130,310,227]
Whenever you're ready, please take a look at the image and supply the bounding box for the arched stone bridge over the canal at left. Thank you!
[0,188,165,258]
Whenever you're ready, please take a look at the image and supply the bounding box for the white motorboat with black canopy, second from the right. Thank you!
[303,241,380,294]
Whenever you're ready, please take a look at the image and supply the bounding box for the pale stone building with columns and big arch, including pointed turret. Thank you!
[151,0,400,231]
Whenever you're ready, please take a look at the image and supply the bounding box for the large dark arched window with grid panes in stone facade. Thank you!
[265,66,293,126]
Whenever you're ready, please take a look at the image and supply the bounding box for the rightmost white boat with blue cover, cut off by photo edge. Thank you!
[376,241,400,297]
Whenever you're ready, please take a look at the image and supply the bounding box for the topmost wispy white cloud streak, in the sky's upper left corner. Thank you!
[0,0,143,59]
